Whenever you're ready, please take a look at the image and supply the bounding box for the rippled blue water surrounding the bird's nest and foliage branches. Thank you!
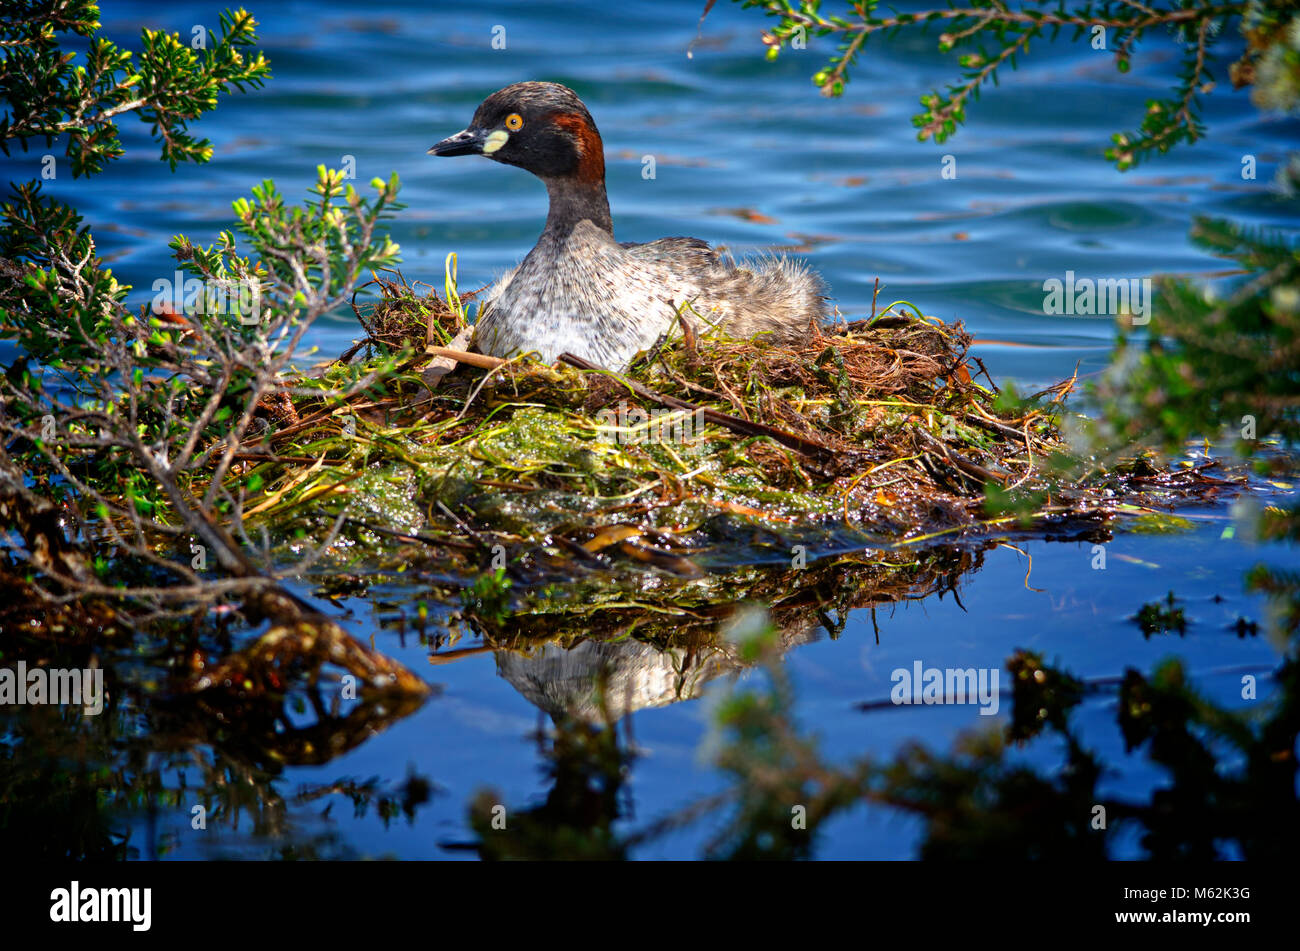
[4,0,1300,857]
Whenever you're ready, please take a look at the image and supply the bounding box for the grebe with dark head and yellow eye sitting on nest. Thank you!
[429,82,826,370]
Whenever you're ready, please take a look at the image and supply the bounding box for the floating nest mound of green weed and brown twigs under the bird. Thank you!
[226,267,1226,583]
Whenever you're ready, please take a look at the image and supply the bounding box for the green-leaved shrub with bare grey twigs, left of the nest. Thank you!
[0,169,400,569]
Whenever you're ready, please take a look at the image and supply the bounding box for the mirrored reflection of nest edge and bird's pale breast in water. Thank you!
[482,550,983,722]
